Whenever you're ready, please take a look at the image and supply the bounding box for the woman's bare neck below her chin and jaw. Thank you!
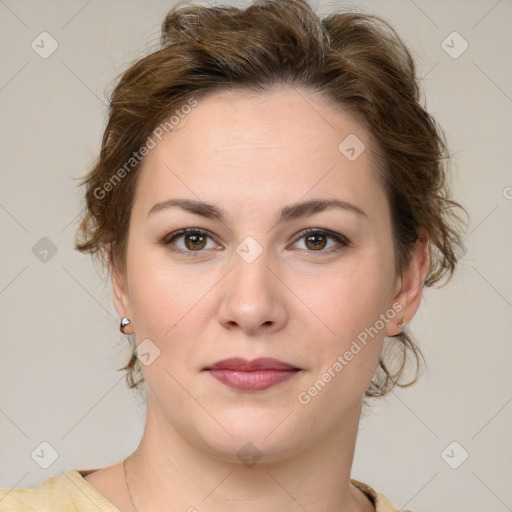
[126,400,373,512]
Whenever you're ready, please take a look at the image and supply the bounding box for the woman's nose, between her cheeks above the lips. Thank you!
[218,251,288,335]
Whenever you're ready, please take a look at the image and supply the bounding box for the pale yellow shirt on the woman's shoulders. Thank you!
[0,469,404,512]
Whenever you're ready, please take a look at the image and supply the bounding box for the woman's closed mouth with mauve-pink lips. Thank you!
[204,357,301,392]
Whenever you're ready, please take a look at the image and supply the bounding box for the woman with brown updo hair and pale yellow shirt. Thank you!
[0,0,461,512]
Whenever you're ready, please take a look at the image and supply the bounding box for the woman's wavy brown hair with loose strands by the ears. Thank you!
[76,0,464,396]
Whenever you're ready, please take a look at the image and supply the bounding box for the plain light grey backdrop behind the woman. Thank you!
[0,0,512,512]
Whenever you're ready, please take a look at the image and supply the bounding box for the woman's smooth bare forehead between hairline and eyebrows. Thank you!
[135,87,382,222]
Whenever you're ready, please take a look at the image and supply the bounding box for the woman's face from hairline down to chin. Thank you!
[113,88,422,461]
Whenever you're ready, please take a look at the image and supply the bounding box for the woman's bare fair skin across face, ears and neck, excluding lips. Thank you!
[86,87,429,512]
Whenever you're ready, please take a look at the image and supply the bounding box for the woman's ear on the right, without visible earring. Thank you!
[386,230,430,336]
